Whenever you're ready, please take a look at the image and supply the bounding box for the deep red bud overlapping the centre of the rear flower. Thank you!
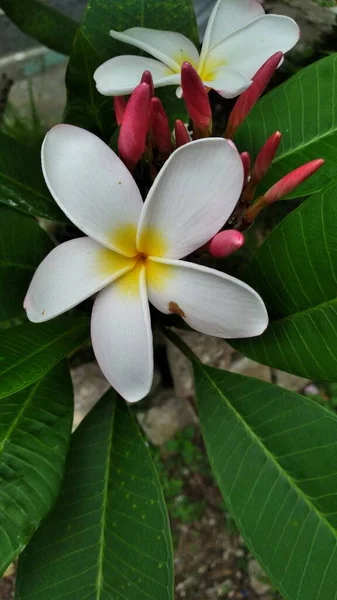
[181,62,212,133]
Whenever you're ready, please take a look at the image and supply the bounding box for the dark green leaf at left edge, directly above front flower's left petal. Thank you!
[0,206,53,329]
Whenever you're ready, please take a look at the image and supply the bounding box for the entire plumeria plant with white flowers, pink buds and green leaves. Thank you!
[0,0,337,600]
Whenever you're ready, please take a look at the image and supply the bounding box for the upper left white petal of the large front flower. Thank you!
[42,125,143,256]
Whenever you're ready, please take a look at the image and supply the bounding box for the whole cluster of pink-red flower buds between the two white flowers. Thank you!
[114,52,324,258]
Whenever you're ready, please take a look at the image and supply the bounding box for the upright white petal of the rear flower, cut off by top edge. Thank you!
[201,0,264,62]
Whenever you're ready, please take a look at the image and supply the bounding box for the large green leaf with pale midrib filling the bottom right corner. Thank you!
[194,363,337,600]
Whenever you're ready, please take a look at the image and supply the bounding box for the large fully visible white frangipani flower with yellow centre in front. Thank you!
[24,125,268,402]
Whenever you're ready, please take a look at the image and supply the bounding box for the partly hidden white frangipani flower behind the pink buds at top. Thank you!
[94,0,300,98]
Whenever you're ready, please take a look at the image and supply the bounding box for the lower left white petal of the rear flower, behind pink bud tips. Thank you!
[94,55,180,96]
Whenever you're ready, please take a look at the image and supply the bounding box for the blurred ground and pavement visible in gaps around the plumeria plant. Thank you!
[0,0,337,600]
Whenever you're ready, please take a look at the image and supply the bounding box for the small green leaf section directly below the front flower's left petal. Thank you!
[0,317,88,398]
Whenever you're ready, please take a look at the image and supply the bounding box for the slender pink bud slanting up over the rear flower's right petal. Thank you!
[225,52,283,138]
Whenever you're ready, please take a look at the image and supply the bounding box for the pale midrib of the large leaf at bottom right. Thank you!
[195,361,337,538]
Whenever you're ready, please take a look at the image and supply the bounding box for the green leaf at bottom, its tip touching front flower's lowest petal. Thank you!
[17,391,173,600]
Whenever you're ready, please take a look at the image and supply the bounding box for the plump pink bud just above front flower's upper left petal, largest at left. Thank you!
[118,83,151,171]
